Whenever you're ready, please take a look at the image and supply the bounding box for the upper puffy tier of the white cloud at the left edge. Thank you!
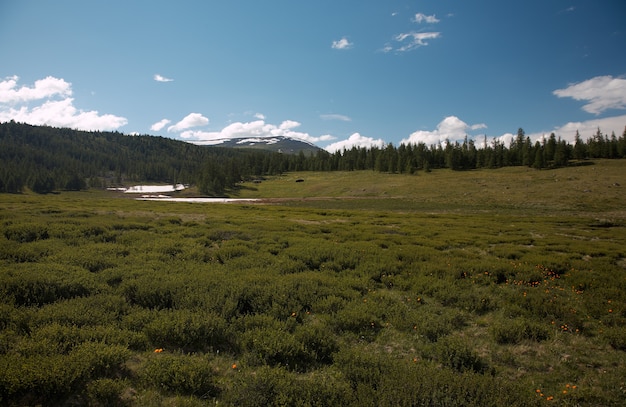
[0,76,72,103]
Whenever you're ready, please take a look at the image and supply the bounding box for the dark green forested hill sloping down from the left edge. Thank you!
[0,122,284,194]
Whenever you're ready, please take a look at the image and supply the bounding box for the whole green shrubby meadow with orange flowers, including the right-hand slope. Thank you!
[0,160,626,406]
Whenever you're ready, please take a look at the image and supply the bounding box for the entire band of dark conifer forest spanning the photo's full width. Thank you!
[0,121,626,195]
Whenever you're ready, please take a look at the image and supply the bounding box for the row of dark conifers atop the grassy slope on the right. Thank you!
[302,128,626,174]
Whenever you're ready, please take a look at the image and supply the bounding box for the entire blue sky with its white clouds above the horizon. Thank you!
[0,0,626,150]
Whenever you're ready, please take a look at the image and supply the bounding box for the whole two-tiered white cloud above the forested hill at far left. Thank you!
[0,76,128,130]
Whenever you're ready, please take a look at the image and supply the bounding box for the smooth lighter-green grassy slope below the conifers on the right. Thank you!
[237,160,626,218]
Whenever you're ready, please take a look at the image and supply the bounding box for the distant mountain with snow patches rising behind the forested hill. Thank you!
[197,136,321,155]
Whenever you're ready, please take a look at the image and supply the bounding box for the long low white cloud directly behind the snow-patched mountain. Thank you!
[180,120,335,144]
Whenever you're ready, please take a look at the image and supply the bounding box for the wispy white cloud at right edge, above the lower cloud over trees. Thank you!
[552,75,626,115]
